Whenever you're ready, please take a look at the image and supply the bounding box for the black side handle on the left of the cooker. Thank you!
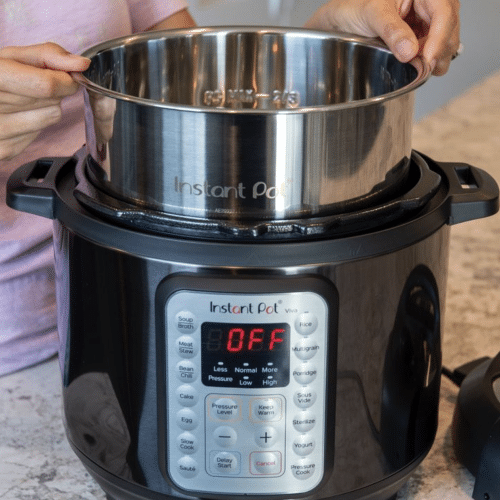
[6,157,72,219]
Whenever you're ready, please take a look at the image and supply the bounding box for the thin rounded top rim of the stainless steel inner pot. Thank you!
[70,26,431,115]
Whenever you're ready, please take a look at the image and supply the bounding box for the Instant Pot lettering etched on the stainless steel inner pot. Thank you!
[174,176,293,200]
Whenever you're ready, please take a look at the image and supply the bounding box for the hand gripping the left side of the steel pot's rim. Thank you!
[0,43,90,160]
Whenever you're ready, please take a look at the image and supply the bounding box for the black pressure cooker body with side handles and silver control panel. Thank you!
[7,153,498,500]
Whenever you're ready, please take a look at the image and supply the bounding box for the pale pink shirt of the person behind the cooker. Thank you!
[0,0,187,375]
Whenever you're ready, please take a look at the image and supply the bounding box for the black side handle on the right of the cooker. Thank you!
[437,163,499,226]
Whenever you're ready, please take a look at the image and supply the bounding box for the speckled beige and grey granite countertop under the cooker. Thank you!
[0,73,500,500]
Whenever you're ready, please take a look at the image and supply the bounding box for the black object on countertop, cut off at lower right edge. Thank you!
[452,353,500,500]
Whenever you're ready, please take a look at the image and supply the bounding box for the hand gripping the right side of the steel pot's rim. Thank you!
[306,0,460,75]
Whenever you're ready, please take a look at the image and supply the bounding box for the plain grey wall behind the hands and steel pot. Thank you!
[188,0,500,120]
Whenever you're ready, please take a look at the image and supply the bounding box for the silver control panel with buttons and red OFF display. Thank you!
[160,278,336,495]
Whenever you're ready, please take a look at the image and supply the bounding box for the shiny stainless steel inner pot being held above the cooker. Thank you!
[74,27,429,220]
